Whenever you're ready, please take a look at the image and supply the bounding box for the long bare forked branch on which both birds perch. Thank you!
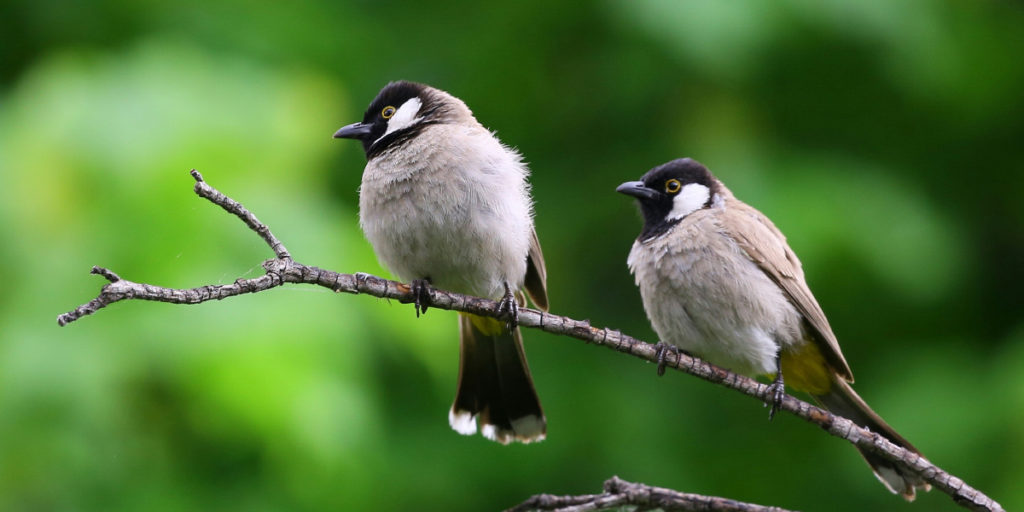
[57,169,1002,511]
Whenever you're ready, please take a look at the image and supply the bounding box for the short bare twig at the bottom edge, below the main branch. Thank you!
[505,476,792,512]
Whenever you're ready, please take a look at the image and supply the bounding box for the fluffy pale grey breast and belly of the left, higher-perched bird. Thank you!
[359,157,532,298]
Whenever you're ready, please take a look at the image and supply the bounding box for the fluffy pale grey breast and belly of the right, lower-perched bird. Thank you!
[629,221,803,376]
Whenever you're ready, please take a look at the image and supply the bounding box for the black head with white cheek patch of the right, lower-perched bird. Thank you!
[615,159,720,240]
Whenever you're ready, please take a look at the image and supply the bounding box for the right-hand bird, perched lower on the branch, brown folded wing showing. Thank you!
[616,158,930,501]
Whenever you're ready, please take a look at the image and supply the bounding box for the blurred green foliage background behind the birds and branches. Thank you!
[0,0,1024,511]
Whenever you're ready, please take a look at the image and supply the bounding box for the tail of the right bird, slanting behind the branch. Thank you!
[812,376,932,501]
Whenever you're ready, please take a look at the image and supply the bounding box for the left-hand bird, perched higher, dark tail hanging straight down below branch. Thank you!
[334,81,548,444]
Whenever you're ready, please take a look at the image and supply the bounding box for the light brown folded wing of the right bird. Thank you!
[723,194,853,382]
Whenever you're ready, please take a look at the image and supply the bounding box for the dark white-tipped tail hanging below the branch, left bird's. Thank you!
[449,313,547,444]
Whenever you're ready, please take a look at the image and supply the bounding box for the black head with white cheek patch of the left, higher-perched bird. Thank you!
[334,81,443,160]
